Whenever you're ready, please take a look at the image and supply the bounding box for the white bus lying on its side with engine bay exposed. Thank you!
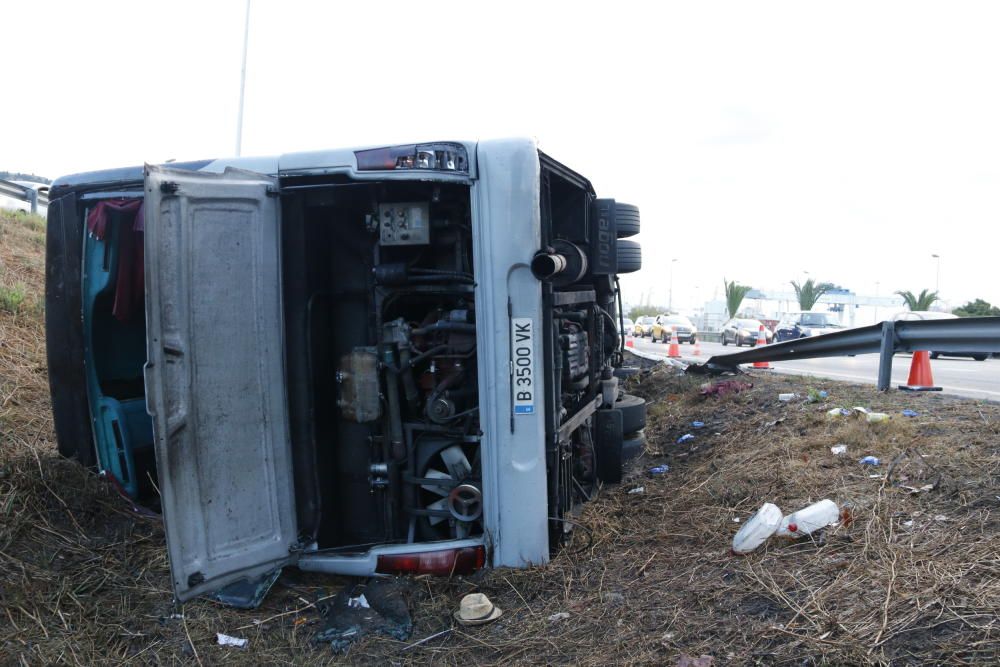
[46,140,645,604]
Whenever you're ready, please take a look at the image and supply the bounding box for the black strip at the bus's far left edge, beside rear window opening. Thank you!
[45,194,97,467]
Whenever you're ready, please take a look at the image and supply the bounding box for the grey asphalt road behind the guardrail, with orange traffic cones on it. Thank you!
[631,338,1000,401]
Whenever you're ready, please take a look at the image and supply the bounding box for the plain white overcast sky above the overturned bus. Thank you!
[0,0,1000,307]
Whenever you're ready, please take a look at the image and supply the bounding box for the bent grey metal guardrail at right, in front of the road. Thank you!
[687,317,1000,391]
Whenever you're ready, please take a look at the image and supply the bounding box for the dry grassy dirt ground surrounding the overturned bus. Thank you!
[0,215,1000,665]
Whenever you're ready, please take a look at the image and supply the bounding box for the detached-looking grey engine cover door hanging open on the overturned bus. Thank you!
[145,167,296,600]
